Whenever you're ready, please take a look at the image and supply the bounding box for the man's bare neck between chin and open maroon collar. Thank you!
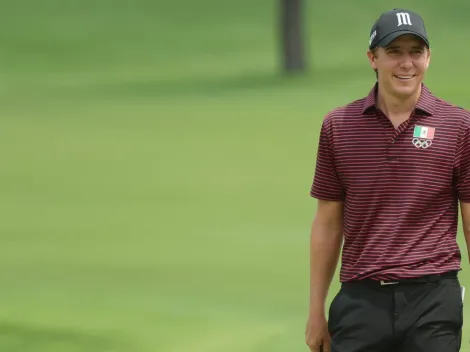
[377,86,421,119]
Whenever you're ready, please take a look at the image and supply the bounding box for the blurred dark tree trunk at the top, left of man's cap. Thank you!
[280,0,305,73]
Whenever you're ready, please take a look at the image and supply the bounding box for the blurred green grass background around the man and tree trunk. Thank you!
[0,0,470,352]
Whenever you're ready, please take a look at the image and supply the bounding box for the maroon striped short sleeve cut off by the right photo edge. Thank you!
[454,127,470,202]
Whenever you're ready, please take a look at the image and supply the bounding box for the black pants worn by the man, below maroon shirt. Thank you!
[328,278,463,352]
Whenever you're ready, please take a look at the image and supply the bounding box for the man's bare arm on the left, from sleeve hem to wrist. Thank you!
[309,200,344,317]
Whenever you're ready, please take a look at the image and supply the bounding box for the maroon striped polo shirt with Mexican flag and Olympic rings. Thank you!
[310,85,470,282]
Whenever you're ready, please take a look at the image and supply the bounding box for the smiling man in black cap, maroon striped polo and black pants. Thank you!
[306,9,470,352]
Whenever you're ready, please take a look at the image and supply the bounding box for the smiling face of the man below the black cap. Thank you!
[367,34,431,98]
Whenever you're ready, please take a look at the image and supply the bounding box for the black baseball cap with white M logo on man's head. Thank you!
[369,9,429,49]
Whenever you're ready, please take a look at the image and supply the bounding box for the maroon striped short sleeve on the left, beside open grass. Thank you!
[310,117,344,201]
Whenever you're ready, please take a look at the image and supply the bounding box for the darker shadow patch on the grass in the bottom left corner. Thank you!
[0,322,134,352]
